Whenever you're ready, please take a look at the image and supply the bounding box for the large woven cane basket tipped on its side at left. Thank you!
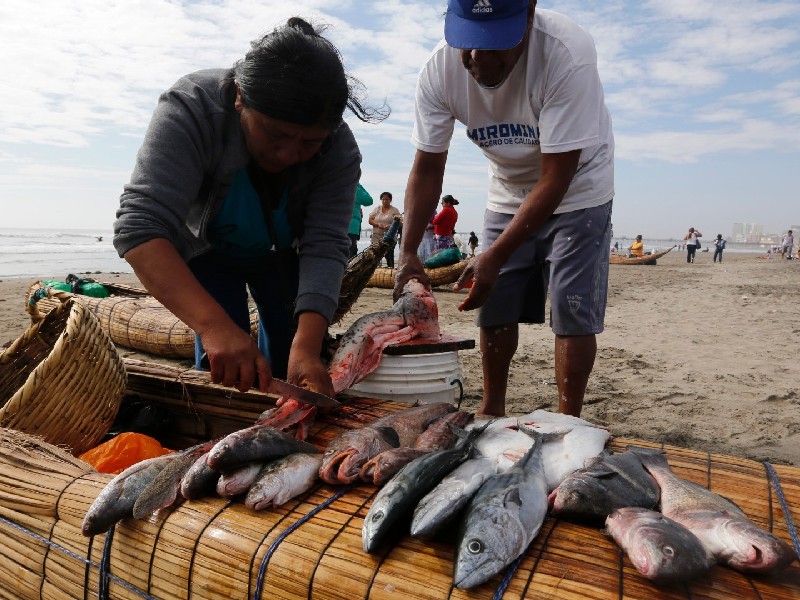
[0,288,126,455]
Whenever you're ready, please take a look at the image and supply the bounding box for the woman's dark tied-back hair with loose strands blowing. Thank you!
[233,17,389,129]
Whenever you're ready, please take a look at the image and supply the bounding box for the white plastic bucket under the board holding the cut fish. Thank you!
[350,351,463,404]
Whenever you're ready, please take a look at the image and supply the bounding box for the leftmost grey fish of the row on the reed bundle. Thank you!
[81,452,176,536]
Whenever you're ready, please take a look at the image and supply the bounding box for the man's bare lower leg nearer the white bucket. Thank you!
[478,323,519,417]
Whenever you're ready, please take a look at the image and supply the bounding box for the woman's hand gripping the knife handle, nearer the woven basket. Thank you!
[199,322,272,392]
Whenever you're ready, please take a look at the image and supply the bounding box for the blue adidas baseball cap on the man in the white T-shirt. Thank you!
[444,0,530,50]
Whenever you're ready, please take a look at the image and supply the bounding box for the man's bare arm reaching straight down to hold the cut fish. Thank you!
[394,150,447,299]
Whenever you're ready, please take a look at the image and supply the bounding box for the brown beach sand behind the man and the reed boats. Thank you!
[0,251,800,466]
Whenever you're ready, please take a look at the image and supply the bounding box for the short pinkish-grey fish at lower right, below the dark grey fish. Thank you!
[605,507,715,583]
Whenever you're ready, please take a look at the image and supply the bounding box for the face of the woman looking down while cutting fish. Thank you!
[235,93,330,173]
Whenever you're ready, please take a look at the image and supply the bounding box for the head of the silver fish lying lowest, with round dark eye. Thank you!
[453,511,525,590]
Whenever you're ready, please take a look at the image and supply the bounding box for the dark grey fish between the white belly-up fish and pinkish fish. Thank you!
[549,447,662,522]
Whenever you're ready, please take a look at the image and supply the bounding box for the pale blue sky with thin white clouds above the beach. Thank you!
[0,0,800,239]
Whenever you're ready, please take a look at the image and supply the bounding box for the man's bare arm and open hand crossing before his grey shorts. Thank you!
[456,150,581,310]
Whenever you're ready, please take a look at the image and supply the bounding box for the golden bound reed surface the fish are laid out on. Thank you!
[0,399,800,600]
